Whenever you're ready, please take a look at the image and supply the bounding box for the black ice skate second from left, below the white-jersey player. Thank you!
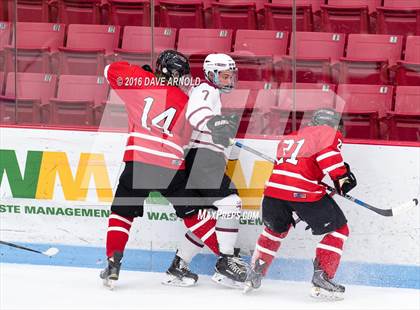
[162,255,198,286]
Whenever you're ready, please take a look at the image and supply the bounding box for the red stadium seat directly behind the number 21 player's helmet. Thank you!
[269,83,335,134]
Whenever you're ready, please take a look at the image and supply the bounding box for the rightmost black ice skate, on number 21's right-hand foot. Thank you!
[311,259,345,300]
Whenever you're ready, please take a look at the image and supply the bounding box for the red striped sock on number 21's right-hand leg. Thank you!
[316,224,349,279]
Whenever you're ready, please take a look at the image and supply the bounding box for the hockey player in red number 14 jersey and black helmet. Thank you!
[100,50,197,286]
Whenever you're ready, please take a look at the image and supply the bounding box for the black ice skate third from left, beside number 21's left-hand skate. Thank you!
[211,254,249,289]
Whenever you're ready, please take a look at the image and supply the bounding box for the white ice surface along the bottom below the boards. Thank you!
[0,264,420,310]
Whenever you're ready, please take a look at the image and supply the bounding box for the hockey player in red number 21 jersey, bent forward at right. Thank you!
[246,109,356,299]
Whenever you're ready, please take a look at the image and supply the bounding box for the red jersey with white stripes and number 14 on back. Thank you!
[104,62,191,170]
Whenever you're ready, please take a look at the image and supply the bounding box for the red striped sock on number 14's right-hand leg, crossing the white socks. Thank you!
[184,214,220,256]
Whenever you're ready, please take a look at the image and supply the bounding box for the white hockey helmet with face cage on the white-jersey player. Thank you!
[203,54,238,93]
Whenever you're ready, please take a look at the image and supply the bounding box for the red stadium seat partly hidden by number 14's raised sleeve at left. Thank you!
[49,75,108,126]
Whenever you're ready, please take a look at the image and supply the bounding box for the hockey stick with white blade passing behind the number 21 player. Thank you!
[234,141,419,216]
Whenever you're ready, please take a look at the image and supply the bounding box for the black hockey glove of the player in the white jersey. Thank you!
[207,114,239,147]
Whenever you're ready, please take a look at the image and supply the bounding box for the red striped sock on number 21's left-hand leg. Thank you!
[251,227,290,276]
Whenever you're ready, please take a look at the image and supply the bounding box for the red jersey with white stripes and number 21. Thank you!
[264,125,347,202]
